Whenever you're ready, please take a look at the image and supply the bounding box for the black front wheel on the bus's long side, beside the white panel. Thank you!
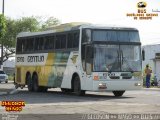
[73,76,85,96]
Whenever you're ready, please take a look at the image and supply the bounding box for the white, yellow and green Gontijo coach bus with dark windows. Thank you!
[15,23,142,96]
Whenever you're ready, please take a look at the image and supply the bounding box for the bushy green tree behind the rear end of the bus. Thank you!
[3,17,40,62]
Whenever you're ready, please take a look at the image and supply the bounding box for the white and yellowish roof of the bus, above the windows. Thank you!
[17,22,137,37]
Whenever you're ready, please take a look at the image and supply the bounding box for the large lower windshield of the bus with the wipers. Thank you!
[93,44,141,72]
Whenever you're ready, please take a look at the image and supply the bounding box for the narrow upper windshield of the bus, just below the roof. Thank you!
[82,29,140,42]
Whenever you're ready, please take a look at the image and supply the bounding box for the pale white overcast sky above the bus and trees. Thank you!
[0,0,160,45]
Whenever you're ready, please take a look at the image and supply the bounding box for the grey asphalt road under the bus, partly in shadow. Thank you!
[0,83,160,120]
